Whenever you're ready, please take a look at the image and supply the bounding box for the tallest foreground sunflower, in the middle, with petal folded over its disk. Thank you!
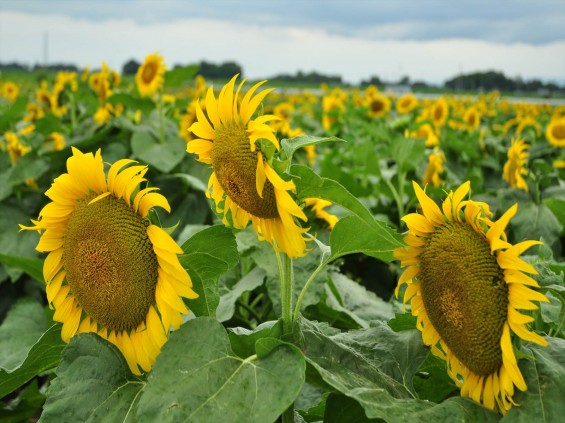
[186,75,307,257]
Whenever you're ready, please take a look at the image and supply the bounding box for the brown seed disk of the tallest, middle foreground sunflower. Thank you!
[211,124,279,219]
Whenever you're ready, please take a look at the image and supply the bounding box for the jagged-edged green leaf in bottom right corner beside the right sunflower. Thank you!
[501,338,565,423]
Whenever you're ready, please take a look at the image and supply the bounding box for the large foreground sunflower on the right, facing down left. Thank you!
[394,182,547,414]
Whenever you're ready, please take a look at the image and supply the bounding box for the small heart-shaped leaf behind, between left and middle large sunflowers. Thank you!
[131,132,186,173]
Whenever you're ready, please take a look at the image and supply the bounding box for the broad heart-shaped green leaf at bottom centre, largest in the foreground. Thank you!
[137,317,305,423]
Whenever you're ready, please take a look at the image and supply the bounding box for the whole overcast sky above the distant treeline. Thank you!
[0,0,565,83]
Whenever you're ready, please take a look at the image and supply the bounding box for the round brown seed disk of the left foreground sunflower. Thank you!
[63,195,159,331]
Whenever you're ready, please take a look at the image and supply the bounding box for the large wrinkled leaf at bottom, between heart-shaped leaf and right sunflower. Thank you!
[299,319,496,423]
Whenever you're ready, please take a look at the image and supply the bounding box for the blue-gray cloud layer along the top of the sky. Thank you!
[0,0,565,44]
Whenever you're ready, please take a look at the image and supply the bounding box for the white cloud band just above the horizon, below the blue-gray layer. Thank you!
[0,12,565,83]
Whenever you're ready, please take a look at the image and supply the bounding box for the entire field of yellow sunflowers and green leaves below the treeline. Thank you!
[0,54,565,423]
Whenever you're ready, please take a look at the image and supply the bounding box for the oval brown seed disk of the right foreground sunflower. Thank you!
[420,223,508,375]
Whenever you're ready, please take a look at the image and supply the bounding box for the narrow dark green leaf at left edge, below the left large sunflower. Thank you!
[0,324,65,398]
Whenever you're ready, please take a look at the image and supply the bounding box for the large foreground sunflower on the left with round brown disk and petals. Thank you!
[20,147,197,374]
